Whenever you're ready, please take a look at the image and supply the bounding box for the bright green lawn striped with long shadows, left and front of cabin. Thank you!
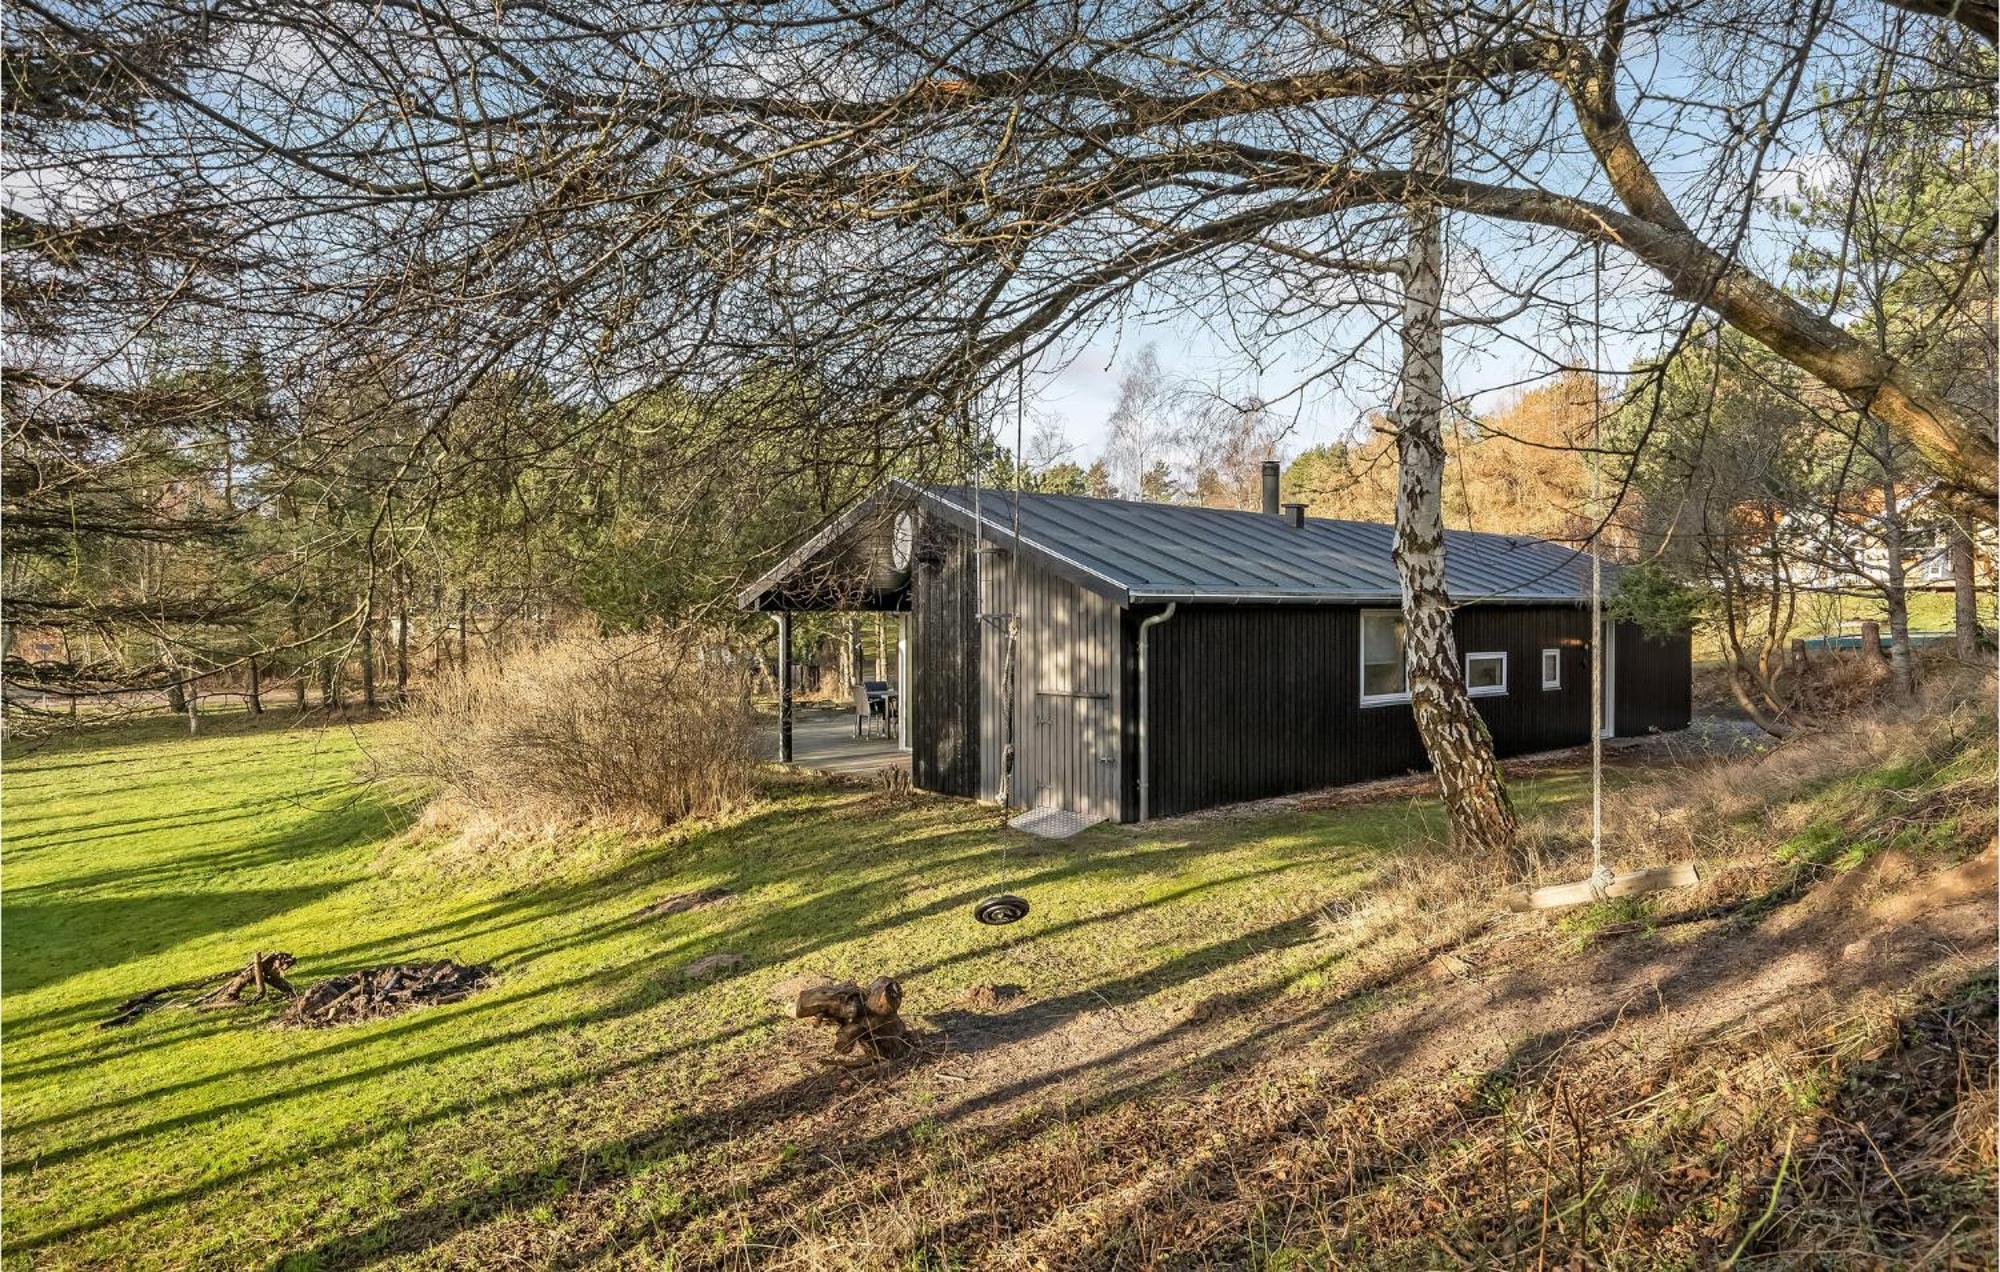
[0,718,1528,1266]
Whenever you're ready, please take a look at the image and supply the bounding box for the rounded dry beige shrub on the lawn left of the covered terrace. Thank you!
[398,632,756,834]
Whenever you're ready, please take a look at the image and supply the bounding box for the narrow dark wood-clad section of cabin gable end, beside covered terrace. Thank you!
[910,526,980,796]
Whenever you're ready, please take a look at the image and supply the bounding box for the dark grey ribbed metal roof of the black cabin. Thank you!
[742,480,1616,608]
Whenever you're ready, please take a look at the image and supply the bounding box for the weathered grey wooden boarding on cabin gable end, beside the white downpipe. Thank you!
[980,552,1124,818]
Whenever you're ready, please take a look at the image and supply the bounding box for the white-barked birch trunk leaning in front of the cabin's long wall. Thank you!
[1394,84,1522,870]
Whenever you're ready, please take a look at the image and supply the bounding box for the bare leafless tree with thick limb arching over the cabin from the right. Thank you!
[10,0,1996,844]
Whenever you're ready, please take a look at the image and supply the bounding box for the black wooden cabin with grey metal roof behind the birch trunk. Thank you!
[740,470,1690,822]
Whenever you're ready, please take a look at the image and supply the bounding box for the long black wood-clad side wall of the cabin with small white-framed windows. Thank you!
[1124,606,1632,816]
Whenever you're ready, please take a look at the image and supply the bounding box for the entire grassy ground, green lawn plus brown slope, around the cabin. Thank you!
[0,722,1994,1268]
